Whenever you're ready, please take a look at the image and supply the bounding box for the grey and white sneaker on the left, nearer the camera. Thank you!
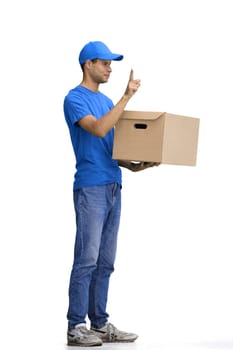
[67,326,102,346]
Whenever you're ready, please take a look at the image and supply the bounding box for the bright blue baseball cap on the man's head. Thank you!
[79,41,124,64]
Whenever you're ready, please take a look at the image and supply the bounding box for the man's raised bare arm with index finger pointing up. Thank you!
[79,70,140,137]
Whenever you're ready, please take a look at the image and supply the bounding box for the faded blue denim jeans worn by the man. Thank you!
[67,183,121,328]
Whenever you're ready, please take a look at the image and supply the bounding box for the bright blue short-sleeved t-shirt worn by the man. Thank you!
[64,85,122,190]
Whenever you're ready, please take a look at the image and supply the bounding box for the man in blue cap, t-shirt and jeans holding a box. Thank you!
[64,41,155,346]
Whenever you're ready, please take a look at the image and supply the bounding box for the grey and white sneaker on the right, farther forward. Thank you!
[91,323,138,343]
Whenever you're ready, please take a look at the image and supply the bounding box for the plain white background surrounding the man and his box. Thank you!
[0,0,233,350]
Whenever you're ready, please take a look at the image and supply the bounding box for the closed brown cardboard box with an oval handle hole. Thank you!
[113,111,200,166]
